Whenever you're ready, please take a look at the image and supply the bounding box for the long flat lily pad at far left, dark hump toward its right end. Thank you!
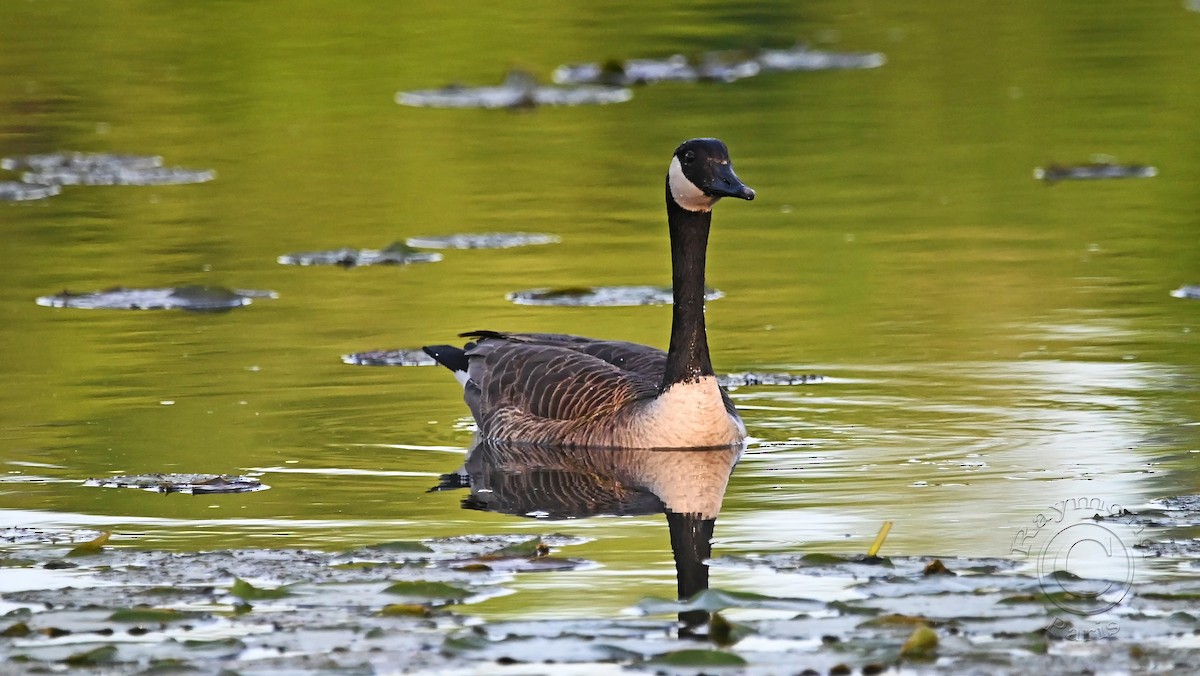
[37,286,278,312]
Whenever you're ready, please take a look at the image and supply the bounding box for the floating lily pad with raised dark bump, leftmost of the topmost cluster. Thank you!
[396,71,634,108]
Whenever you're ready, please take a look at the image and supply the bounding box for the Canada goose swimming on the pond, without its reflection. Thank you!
[424,138,755,448]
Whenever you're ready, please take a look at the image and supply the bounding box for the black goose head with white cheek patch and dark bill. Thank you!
[667,138,754,211]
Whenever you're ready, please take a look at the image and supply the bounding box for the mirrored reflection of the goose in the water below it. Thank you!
[432,441,744,634]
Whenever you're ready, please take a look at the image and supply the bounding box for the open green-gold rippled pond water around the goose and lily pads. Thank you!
[0,1,1200,620]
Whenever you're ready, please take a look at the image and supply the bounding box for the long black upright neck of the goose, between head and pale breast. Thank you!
[662,184,713,390]
